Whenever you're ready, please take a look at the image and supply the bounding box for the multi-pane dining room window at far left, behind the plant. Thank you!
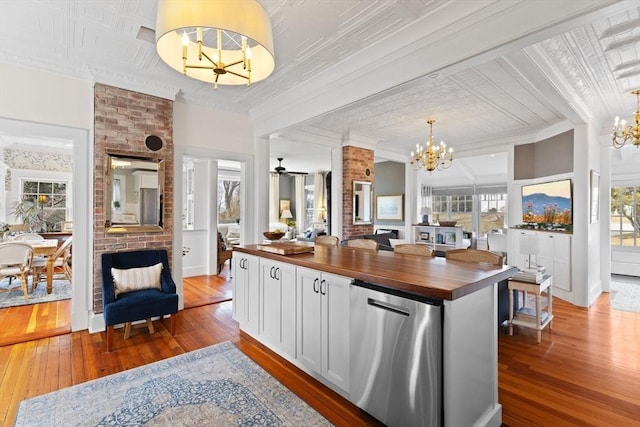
[21,179,68,231]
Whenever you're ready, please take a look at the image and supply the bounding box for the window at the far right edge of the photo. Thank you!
[611,187,640,247]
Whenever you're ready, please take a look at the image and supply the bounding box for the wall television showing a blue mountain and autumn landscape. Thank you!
[522,179,573,225]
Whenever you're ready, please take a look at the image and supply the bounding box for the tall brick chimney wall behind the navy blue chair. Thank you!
[93,84,173,313]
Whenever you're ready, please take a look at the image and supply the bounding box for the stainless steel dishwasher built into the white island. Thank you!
[350,280,443,427]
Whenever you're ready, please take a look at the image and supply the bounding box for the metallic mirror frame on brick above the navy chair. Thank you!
[104,153,165,233]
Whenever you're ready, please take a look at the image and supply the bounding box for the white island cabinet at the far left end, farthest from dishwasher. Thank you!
[231,252,260,337]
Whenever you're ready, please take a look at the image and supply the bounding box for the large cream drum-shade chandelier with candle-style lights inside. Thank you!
[156,0,275,89]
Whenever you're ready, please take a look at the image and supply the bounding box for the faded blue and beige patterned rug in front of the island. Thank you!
[15,341,330,426]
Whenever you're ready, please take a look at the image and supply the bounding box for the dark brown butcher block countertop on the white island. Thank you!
[233,245,518,300]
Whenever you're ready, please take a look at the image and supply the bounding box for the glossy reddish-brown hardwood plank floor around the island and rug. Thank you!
[0,270,640,427]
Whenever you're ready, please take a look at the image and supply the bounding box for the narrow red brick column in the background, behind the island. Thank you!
[342,146,374,239]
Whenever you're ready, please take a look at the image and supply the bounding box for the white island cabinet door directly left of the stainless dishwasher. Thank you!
[320,273,351,391]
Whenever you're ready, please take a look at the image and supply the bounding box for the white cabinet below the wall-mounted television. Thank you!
[509,229,573,298]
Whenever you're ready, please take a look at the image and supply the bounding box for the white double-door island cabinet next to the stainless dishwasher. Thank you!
[296,267,351,391]
